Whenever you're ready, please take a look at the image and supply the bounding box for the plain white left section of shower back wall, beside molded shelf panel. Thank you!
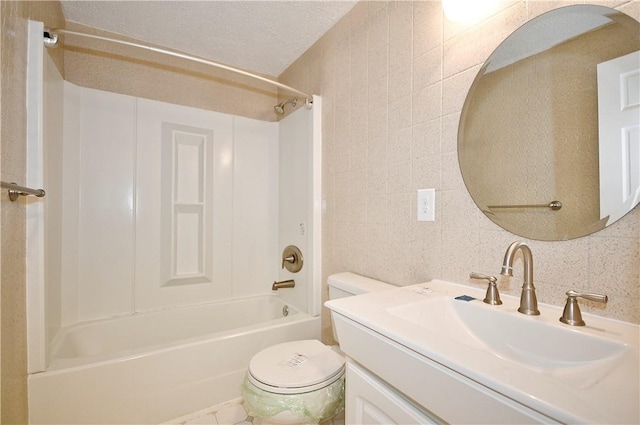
[62,84,136,324]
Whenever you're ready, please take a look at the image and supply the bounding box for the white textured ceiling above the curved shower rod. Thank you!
[62,0,356,77]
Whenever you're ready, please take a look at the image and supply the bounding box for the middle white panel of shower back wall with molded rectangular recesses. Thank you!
[134,99,233,311]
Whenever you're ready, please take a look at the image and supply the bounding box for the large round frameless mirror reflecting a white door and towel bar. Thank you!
[458,5,640,241]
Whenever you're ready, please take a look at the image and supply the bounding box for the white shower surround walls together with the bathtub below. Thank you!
[27,41,321,423]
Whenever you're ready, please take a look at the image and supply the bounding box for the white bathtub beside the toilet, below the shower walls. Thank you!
[29,295,320,424]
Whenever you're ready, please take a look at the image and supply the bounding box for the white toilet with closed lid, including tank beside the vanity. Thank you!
[242,272,393,425]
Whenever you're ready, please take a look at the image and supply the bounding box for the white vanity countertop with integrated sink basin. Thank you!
[326,280,640,424]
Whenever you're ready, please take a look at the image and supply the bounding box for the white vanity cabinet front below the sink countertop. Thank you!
[333,314,560,425]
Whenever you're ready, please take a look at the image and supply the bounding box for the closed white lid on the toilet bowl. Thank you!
[249,340,344,392]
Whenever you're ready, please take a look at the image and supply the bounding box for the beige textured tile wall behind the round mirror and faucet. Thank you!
[279,0,640,332]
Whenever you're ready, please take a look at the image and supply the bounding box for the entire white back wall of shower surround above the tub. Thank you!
[56,82,279,326]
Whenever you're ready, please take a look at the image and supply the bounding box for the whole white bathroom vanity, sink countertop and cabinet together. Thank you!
[326,280,640,424]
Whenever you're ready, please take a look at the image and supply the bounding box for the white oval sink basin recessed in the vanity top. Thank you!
[386,296,626,370]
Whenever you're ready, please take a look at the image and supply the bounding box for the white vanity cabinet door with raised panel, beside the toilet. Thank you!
[345,361,444,425]
